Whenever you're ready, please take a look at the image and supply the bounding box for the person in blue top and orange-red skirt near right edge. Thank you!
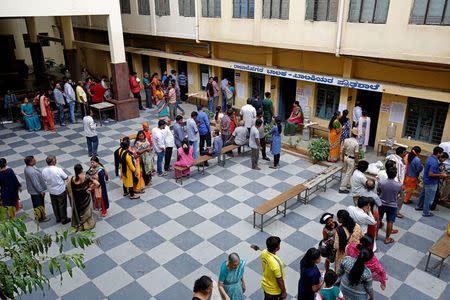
[403,146,423,204]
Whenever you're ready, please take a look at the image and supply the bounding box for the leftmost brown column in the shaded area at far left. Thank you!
[25,17,46,83]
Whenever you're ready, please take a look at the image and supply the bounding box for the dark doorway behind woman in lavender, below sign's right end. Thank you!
[356,90,383,146]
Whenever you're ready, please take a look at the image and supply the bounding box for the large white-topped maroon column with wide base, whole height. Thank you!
[107,1,139,121]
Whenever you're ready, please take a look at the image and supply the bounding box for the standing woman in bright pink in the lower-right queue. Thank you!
[345,234,388,291]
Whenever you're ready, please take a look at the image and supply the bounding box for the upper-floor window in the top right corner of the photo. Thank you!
[409,0,450,25]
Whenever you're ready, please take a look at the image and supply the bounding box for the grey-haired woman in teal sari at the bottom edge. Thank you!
[218,253,247,300]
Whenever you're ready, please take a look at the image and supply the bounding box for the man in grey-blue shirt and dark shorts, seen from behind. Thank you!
[378,168,402,244]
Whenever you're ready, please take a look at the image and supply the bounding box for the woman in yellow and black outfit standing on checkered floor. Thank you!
[114,138,140,199]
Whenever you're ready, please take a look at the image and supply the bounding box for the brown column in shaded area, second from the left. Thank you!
[60,16,81,82]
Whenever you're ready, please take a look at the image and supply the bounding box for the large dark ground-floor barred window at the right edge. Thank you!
[403,98,448,144]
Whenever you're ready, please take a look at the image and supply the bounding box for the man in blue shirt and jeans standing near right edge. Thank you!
[416,147,447,217]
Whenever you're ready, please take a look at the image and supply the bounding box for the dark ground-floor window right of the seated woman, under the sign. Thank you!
[316,84,341,120]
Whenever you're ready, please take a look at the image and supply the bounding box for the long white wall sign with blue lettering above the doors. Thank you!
[230,63,383,92]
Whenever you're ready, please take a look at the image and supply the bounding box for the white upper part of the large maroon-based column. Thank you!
[107,0,126,64]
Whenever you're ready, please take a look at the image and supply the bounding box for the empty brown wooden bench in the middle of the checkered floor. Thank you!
[253,184,306,231]
